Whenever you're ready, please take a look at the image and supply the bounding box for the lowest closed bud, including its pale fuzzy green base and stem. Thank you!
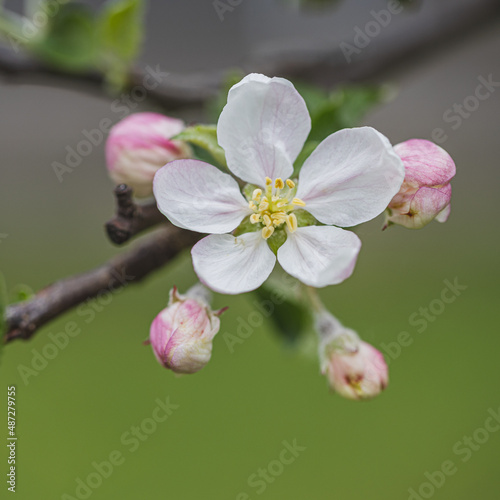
[316,311,389,399]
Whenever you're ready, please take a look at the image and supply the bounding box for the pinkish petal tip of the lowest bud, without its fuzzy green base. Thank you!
[323,341,389,399]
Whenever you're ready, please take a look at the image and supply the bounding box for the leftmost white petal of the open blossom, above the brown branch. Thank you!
[153,160,252,233]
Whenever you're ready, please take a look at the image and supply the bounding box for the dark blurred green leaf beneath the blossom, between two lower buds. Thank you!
[255,275,312,345]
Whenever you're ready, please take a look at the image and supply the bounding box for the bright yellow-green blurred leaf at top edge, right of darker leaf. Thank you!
[99,0,144,63]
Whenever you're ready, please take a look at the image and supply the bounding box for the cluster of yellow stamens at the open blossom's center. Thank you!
[248,177,306,240]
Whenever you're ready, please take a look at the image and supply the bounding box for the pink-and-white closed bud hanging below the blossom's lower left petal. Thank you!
[149,288,221,373]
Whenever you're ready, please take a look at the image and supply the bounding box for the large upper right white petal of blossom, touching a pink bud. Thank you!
[297,127,405,227]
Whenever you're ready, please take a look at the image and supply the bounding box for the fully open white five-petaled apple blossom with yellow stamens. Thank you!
[153,74,404,294]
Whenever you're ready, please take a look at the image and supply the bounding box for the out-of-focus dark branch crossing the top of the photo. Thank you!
[0,0,500,109]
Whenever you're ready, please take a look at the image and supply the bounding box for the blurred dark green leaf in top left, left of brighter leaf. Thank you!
[30,4,98,71]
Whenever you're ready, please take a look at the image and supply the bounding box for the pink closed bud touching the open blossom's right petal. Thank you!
[386,139,455,229]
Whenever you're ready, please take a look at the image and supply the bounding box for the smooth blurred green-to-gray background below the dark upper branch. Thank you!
[0,0,500,500]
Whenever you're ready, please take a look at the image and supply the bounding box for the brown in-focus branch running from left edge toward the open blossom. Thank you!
[4,225,202,343]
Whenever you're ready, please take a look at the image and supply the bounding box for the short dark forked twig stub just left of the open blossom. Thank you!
[106,184,167,245]
